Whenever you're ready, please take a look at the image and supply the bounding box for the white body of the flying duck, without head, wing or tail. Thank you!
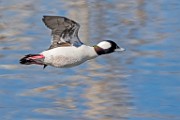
[41,45,98,67]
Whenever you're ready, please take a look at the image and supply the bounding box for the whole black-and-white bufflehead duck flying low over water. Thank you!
[20,16,125,68]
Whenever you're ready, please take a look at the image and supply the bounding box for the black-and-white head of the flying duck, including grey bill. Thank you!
[94,40,125,55]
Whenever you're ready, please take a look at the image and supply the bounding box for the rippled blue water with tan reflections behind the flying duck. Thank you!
[0,0,180,120]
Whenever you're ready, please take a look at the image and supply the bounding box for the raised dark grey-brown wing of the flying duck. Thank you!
[42,16,83,49]
